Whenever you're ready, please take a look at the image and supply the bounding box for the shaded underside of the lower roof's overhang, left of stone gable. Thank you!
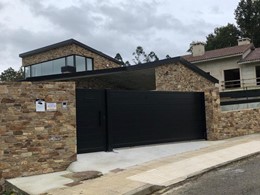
[24,65,156,90]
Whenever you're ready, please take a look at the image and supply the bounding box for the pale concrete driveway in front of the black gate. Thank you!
[68,140,223,174]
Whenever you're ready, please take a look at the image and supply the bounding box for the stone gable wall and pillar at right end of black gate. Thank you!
[155,63,219,139]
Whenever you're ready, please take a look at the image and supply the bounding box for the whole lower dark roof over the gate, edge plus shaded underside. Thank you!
[24,57,218,90]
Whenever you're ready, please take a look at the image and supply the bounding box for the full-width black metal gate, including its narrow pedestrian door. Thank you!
[77,89,206,153]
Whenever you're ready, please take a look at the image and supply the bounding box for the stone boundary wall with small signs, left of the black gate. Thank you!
[0,82,76,191]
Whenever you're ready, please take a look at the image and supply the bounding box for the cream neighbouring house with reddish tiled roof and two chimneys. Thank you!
[182,38,260,91]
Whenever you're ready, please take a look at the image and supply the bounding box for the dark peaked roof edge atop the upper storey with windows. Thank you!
[19,39,122,64]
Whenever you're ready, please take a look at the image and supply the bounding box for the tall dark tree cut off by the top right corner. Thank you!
[235,0,260,47]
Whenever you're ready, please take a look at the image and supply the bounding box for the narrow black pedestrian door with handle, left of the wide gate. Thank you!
[76,89,107,153]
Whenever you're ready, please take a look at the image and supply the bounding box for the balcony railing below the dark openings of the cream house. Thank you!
[221,77,260,91]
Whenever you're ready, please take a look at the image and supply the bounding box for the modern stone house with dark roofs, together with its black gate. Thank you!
[20,40,221,152]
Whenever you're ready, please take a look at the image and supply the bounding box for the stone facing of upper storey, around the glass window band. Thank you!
[22,44,120,70]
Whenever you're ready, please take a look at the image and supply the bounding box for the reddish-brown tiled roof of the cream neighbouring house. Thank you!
[182,43,254,62]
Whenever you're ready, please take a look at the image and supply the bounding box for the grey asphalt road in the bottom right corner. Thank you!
[160,155,260,195]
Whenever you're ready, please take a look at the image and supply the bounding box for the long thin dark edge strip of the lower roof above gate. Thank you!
[21,57,219,83]
